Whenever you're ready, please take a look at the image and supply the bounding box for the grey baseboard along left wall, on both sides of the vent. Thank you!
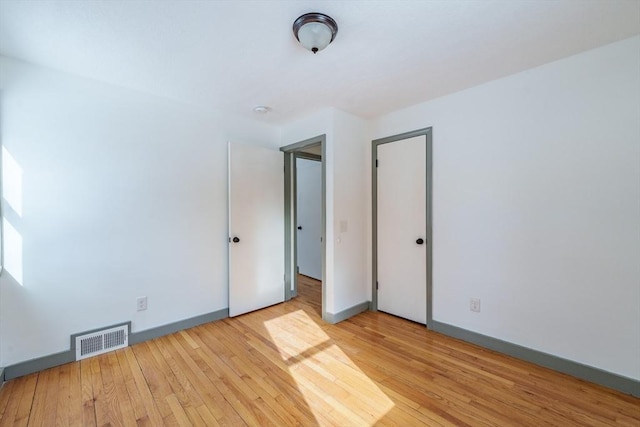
[0,308,229,381]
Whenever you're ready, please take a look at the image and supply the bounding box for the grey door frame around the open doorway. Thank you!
[280,134,327,318]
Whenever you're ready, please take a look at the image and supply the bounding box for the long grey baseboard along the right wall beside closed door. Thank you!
[433,321,640,397]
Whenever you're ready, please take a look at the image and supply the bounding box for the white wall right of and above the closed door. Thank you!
[373,37,640,379]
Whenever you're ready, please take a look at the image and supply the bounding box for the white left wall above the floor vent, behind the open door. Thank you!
[0,59,280,366]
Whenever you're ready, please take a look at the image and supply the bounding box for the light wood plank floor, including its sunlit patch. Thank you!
[0,278,640,427]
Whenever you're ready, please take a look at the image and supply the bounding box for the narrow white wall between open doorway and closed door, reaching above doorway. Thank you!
[281,108,370,314]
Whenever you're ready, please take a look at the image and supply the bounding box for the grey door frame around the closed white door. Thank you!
[371,127,433,329]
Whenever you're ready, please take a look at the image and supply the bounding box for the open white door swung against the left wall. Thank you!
[229,143,284,316]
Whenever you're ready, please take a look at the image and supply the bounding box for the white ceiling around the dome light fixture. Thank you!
[0,0,640,124]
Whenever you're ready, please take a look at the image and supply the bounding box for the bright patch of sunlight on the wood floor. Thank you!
[264,310,394,425]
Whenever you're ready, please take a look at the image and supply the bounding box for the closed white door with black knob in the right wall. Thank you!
[377,135,427,323]
